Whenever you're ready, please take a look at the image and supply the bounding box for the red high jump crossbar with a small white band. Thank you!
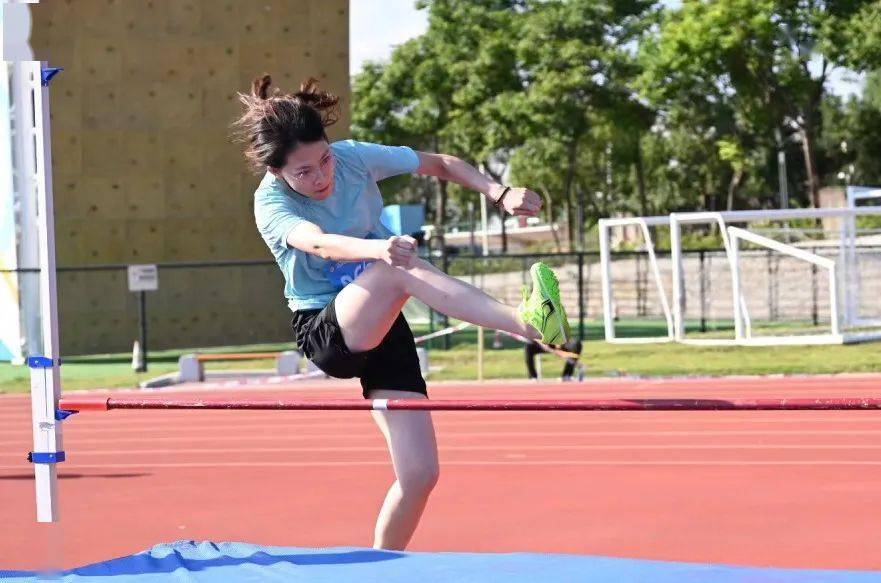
[61,397,881,411]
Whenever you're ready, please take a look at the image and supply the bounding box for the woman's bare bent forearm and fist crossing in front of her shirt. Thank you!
[287,221,416,268]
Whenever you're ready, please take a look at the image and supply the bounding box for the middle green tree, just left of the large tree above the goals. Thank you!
[517,0,654,245]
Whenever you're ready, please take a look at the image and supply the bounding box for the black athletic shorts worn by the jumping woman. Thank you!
[291,299,428,398]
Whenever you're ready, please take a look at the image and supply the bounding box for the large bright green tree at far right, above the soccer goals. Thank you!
[642,0,878,206]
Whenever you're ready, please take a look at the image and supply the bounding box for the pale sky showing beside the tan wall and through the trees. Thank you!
[349,0,865,96]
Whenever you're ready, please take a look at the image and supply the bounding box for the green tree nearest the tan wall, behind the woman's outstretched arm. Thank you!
[353,0,522,249]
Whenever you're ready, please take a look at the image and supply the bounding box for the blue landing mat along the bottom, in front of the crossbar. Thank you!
[0,541,881,583]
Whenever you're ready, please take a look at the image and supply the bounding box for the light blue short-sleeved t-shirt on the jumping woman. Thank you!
[254,140,419,311]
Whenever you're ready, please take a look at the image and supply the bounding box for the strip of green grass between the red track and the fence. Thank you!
[0,322,881,393]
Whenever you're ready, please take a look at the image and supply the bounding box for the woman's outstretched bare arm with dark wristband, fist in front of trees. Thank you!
[416,152,541,216]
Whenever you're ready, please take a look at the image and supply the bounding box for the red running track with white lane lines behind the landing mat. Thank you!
[0,375,881,569]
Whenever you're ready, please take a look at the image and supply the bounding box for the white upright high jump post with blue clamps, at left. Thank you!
[27,61,64,522]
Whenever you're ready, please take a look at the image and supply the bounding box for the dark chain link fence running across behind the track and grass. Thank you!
[2,247,881,355]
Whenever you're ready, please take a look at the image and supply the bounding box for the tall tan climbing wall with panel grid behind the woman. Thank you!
[32,0,349,354]
